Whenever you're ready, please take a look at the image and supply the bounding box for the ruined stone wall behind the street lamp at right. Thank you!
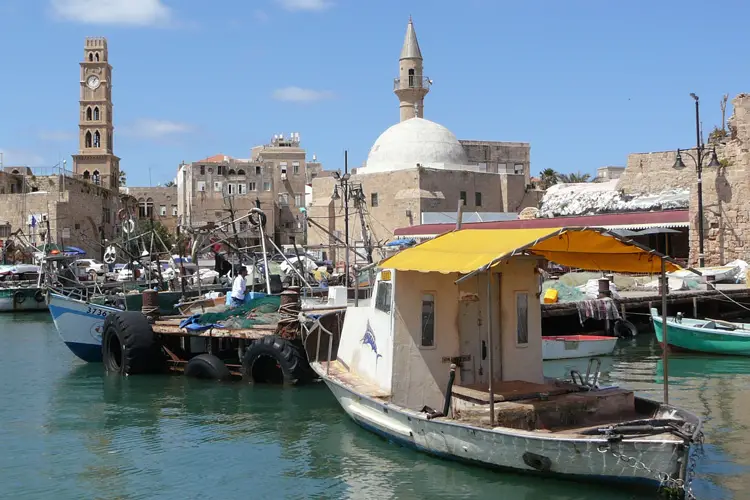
[618,94,750,265]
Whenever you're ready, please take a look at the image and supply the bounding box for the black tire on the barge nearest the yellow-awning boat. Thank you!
[242,335,315,385]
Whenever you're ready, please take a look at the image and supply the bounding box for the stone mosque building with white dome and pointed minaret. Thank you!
[308,19,539,261]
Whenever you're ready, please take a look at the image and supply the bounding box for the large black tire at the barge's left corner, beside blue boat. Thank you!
[102,311,166,375]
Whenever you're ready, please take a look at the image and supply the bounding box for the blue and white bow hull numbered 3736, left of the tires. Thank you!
[49,293,120,363]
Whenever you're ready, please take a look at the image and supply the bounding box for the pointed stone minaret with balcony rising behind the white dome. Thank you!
[393,16,432,121]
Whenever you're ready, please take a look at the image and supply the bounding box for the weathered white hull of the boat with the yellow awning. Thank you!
[312,363,690,487]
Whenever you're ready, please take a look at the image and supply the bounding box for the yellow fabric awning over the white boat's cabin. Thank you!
[379,227,679,274]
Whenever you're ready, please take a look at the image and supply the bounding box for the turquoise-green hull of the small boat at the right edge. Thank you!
[651,314,750,356]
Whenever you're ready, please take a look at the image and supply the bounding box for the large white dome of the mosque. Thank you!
[362,118,471,173]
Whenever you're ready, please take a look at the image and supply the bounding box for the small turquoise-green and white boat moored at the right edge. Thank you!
[651,308,750,356]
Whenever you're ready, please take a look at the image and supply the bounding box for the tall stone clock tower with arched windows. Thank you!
[73,38,120,190]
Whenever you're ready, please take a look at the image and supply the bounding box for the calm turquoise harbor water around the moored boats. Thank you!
[0,313,750,500]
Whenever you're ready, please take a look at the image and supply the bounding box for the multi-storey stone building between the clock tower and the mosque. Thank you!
[177,133,322,245]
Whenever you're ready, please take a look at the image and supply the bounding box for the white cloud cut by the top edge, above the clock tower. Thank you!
[50,0,172,26]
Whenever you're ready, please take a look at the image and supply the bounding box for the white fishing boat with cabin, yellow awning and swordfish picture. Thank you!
[300,228,702,489]
